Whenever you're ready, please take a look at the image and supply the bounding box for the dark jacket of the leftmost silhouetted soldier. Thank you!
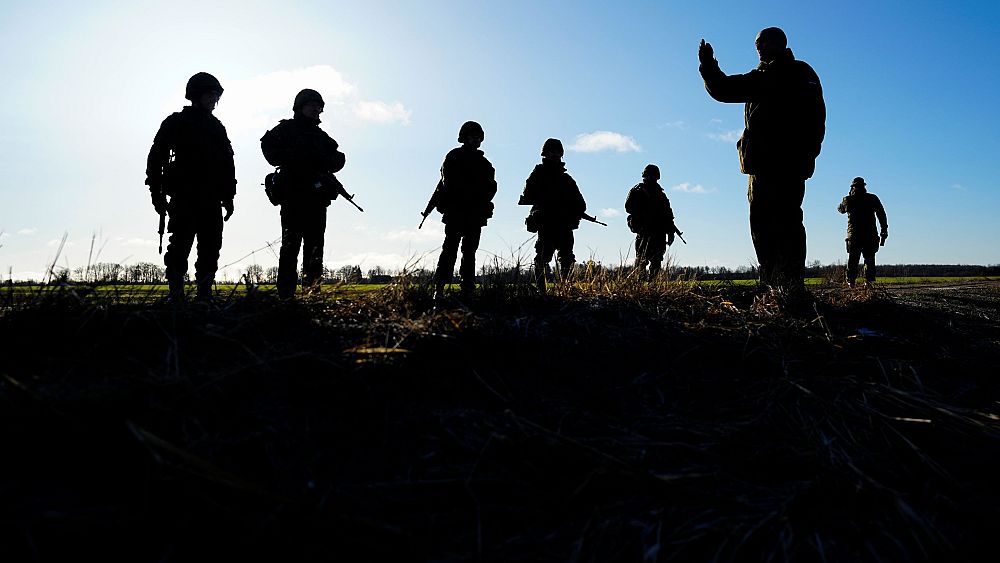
[146,106,236,202]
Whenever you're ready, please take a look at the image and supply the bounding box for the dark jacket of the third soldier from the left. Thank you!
[430,147,497,226]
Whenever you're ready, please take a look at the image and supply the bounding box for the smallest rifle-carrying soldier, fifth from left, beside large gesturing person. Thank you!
[625,164,677,278]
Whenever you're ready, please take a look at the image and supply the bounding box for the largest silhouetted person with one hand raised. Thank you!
[698,27,826,290]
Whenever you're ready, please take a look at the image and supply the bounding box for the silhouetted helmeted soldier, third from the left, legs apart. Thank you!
[422,121,497,301]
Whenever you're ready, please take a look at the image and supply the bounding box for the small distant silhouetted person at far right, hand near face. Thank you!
[837,177,889,287]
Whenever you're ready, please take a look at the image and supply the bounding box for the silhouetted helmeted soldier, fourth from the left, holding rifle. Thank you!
[517,139,587,293]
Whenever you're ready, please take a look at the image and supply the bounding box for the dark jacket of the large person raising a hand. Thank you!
[699,49,826,179]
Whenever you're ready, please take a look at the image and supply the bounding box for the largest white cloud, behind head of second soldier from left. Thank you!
[216,65,411,137]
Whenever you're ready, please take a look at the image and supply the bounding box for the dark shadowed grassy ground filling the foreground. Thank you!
[0,284,1000,562]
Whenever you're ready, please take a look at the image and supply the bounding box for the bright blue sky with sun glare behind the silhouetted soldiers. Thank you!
[0,0,1000,279]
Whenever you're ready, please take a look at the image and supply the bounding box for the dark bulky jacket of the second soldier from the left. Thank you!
[260,115,347,205]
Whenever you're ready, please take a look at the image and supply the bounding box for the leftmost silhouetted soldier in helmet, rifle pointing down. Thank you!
[146,72,236,302]
